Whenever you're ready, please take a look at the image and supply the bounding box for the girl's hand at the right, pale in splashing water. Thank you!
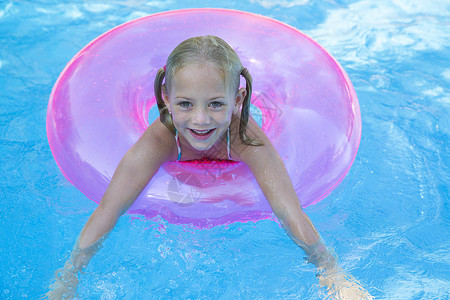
[318,266,374,300]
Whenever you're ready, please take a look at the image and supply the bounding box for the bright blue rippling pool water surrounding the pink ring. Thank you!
[0,0,450,299]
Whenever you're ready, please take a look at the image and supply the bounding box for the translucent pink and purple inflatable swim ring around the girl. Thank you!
[47,9,361,227]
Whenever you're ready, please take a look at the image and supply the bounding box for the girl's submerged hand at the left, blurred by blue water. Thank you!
[45,262,79,300]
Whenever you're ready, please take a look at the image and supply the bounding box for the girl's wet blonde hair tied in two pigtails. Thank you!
[154,35,263,146]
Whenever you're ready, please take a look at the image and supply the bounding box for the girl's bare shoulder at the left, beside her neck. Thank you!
[131,119,177,161]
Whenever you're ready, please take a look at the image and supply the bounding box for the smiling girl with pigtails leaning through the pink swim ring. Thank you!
[47,36,370,299]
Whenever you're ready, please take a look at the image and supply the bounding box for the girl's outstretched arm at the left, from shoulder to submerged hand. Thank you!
[47,120,176,299]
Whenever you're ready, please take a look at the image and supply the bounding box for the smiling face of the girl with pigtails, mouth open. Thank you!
[164,63,246,151]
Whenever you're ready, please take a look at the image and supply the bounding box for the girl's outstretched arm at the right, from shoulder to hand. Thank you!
[237,119,371,299]
